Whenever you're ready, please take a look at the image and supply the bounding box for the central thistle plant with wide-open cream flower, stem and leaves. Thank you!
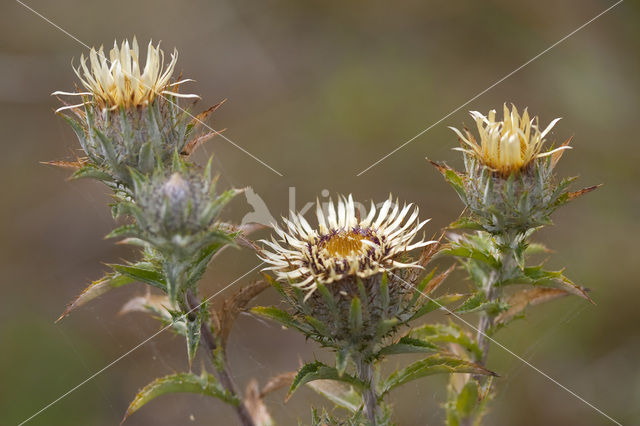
[253,196,492,425]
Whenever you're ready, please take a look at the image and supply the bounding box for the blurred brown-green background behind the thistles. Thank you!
[0,0,640,426]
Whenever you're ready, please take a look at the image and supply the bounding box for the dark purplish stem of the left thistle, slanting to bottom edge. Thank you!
[186,290,255,426]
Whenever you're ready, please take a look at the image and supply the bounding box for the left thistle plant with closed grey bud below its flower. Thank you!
[52,38,270,426]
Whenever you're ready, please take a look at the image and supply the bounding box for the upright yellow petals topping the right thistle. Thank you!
[450,104,569,175]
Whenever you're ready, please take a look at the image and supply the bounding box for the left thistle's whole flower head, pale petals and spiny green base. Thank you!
[53,37,219,188]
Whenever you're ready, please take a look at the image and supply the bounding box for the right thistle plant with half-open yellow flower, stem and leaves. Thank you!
[432,104,596,426]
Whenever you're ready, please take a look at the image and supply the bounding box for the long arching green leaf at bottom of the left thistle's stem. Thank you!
[123,373,240,421]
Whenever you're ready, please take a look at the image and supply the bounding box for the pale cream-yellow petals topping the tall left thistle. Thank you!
[54,37,198,109]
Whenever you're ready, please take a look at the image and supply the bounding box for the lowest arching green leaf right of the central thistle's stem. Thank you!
[381,354,496,395]
